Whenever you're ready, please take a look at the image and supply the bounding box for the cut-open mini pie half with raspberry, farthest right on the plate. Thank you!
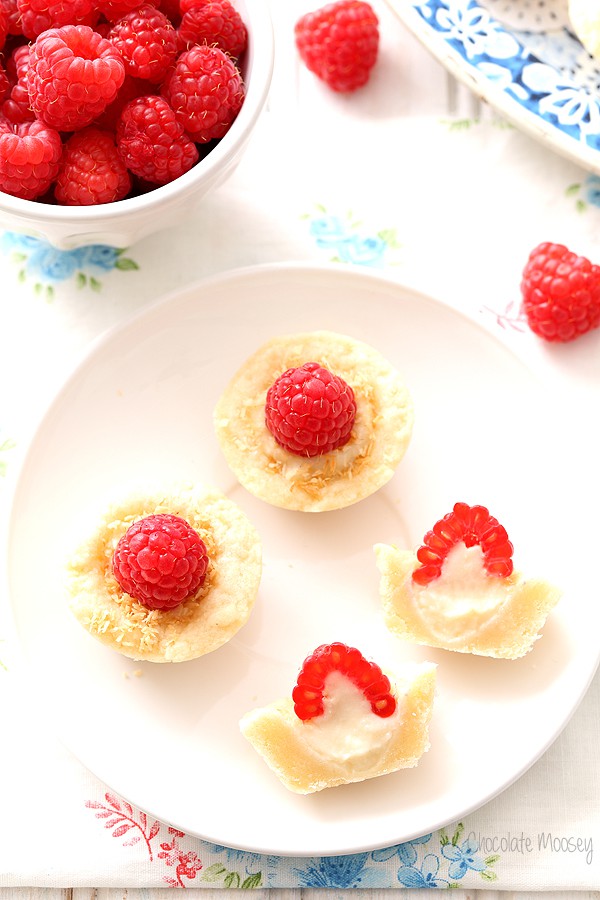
[375,503,560,659]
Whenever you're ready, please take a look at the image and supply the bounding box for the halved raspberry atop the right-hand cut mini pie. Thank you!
[412,503,513,585]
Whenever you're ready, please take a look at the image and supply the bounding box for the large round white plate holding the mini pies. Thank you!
[9,265,598,856]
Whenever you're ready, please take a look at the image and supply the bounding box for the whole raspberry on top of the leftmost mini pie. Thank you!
[112,513,208,609]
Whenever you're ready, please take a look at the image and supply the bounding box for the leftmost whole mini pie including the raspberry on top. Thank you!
[67,487,262,662]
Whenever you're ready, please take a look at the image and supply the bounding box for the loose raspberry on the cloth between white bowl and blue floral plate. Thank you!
[294,0,379,92]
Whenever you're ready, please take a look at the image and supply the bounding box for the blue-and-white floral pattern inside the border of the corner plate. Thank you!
[412,0,600,153]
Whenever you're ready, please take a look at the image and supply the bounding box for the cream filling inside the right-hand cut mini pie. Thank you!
[412,541,509,640]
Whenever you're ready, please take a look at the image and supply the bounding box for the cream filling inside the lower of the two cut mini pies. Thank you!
[300,672,401,772]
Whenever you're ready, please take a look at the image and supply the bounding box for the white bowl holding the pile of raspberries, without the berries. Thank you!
[0,0,274,250]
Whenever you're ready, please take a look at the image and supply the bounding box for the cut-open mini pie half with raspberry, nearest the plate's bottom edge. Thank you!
[240,643,436,794]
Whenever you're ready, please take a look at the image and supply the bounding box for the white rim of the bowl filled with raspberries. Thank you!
[0,0,275,228]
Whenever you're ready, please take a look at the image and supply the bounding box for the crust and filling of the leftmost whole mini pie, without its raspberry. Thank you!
[68,487,262,662]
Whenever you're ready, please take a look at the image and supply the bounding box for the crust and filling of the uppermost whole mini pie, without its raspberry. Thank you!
[214,331,413,512]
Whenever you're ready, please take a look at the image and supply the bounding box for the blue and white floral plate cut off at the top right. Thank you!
[387,0,600,174]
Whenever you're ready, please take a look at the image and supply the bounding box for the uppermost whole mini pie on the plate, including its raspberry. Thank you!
[214,331,413,512]
